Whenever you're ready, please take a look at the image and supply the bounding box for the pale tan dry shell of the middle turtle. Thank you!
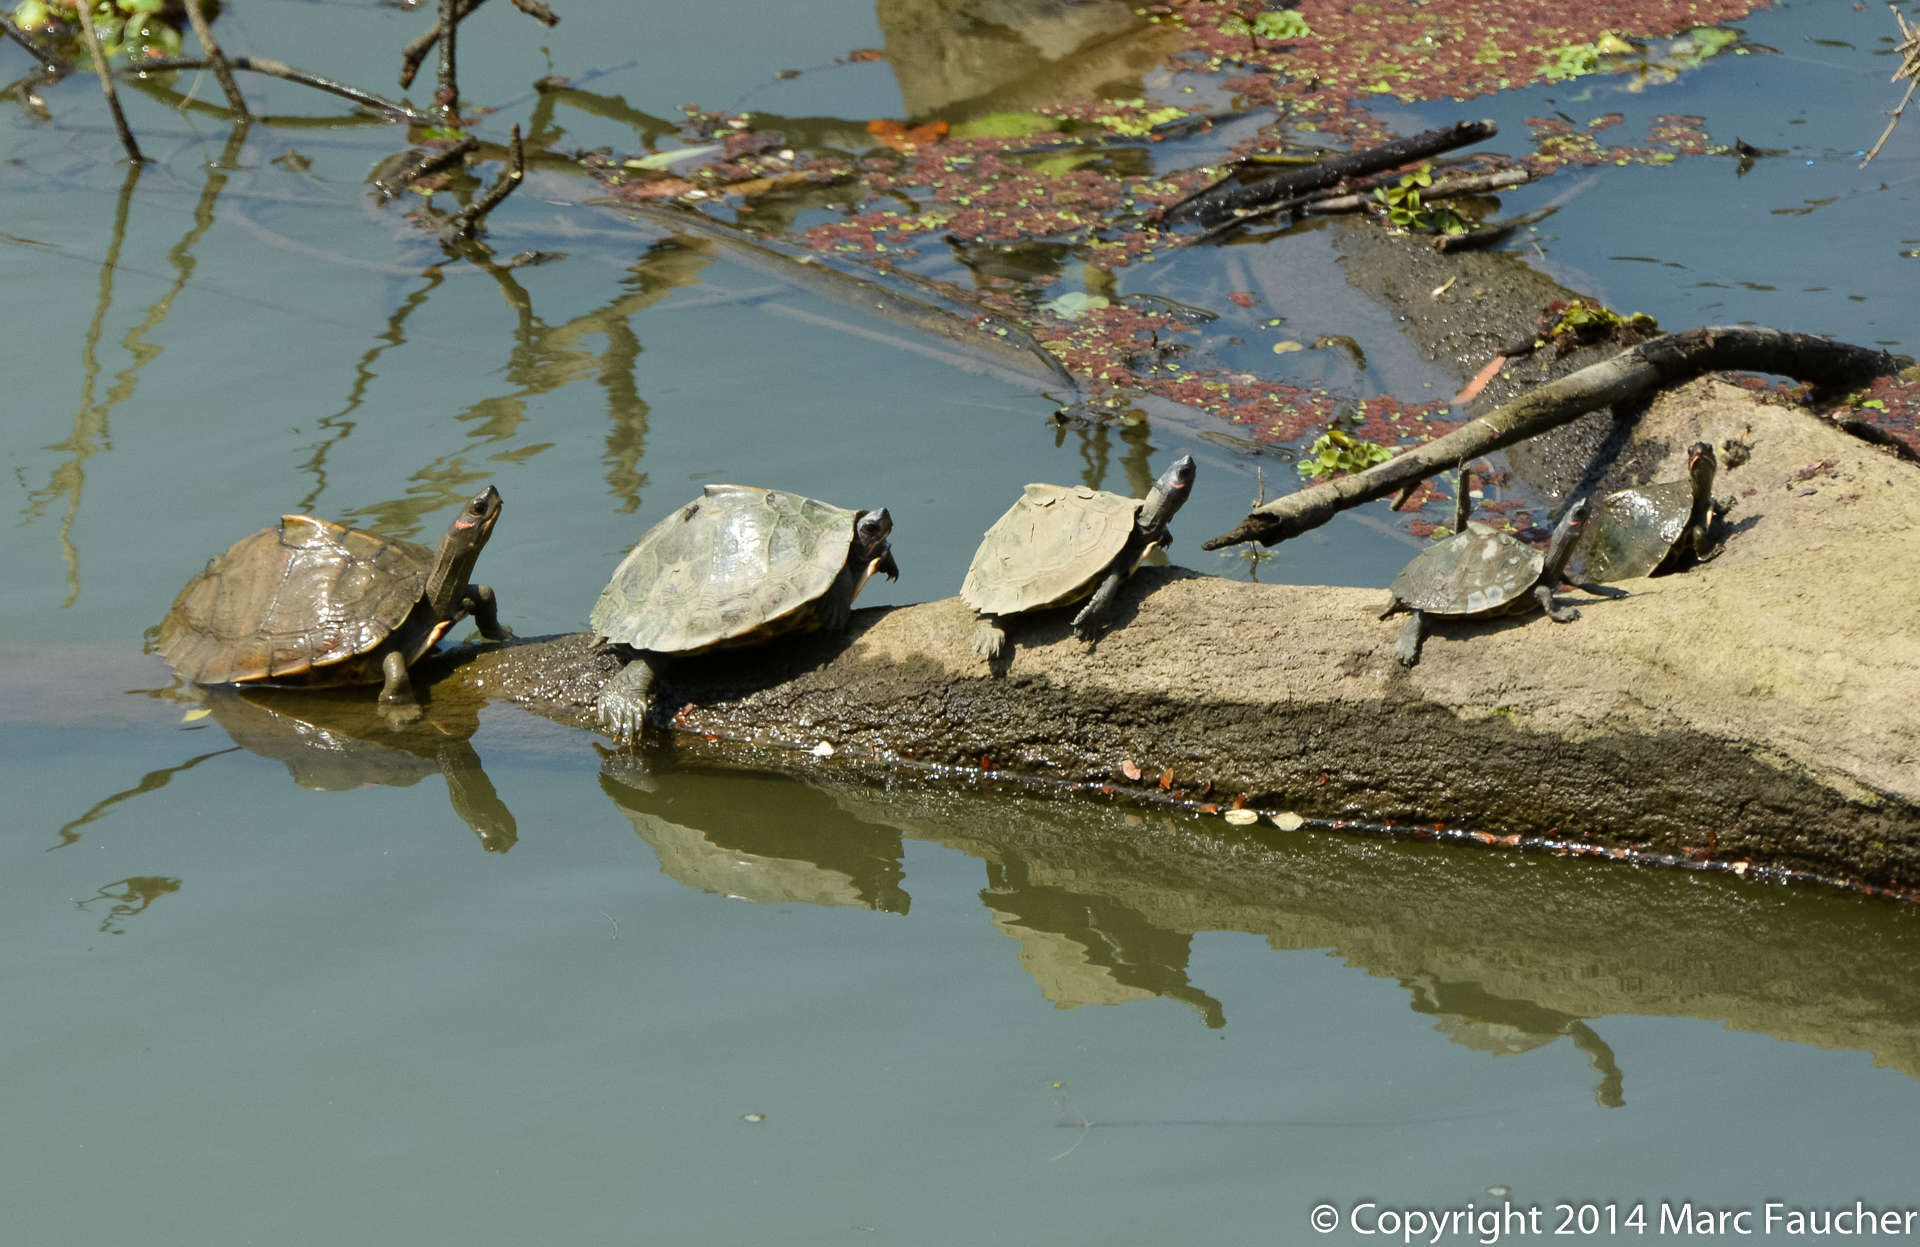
[960,484,1140,615]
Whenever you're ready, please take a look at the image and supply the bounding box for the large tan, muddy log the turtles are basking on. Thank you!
[447,380,1920,888]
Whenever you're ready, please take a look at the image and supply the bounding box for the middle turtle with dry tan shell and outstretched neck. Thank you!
[960,455,1194,663]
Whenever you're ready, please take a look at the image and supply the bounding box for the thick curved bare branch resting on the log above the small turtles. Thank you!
[1202,325,1912,550]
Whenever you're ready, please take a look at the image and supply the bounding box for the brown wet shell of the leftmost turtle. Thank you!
[157,515,451,684]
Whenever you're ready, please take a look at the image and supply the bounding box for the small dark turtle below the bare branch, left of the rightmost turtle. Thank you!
[1380,471,1588,667]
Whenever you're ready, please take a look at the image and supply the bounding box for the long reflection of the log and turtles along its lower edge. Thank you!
[601,757,1920,1083]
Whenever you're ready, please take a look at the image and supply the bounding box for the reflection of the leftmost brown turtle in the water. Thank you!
[204,688,520,853]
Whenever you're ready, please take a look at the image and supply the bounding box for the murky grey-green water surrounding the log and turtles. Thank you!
[0,0,1920,1245]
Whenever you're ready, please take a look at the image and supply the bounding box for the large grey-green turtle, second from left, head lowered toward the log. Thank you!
[589,484,900,742]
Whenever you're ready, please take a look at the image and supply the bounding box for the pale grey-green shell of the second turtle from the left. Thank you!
[589,484,862,653]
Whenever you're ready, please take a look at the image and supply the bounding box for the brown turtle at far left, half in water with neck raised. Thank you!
[156,486,507,717]
